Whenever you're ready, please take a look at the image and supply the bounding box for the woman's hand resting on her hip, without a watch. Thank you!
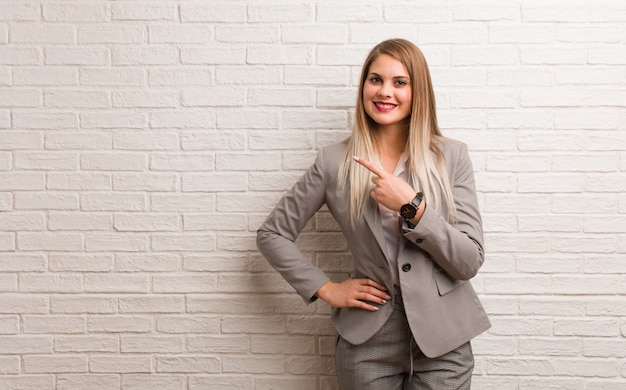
[315,278,391,311]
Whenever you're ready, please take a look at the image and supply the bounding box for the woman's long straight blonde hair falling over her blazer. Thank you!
[339,39,456,226]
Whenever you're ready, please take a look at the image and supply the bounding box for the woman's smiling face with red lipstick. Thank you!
[363,54,413,129]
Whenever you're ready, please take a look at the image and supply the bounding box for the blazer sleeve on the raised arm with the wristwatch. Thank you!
[403,143,485,280]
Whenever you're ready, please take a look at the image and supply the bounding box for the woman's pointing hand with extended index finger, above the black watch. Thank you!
[353,157,416,211]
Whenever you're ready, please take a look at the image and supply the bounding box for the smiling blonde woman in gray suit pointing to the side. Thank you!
[257,39,490,390]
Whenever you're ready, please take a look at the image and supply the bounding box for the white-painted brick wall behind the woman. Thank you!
[0,0,626,390]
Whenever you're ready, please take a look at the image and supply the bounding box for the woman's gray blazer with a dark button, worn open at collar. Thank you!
[257,138,490,357]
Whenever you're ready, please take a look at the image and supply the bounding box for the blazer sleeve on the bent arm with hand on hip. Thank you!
[256,150,330,303]
